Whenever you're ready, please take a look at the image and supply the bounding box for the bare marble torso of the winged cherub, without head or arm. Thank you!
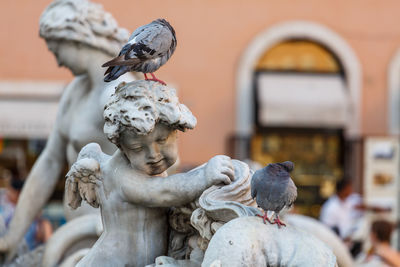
[77,157,168,267]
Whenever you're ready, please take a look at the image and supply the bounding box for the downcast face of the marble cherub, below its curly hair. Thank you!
[120,123,178,175]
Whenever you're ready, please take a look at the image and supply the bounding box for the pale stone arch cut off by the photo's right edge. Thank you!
[388,48,400,135]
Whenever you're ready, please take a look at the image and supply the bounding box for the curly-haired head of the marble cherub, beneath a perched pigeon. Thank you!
[104,80,196,175]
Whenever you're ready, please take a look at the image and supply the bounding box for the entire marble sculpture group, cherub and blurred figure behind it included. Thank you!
[0,0,336,267]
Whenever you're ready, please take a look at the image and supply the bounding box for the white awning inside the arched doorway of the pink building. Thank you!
[257,73,349,128]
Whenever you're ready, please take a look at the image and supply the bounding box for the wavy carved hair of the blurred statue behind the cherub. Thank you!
[39,0,129,56]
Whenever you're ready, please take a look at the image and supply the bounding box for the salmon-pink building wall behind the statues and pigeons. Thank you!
[0,0,400,162]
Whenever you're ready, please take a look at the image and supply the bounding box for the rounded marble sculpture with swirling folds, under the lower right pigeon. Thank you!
[146,160,340,267]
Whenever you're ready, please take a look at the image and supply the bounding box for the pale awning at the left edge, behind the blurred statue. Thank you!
[0,81,65,139]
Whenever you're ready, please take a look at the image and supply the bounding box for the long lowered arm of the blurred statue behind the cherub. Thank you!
[0,123,66,253]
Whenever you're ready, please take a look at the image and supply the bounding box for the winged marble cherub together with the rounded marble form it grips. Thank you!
[62,81,336,267]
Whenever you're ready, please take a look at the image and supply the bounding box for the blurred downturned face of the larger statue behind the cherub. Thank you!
[46,40,87,76]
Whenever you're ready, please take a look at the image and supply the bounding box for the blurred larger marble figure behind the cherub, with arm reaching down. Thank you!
[0,0,138,258]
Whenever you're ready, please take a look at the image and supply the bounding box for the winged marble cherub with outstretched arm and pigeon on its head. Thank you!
[66,81,234,267]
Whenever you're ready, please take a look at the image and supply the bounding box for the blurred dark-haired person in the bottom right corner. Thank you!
[358,220,400,267]
